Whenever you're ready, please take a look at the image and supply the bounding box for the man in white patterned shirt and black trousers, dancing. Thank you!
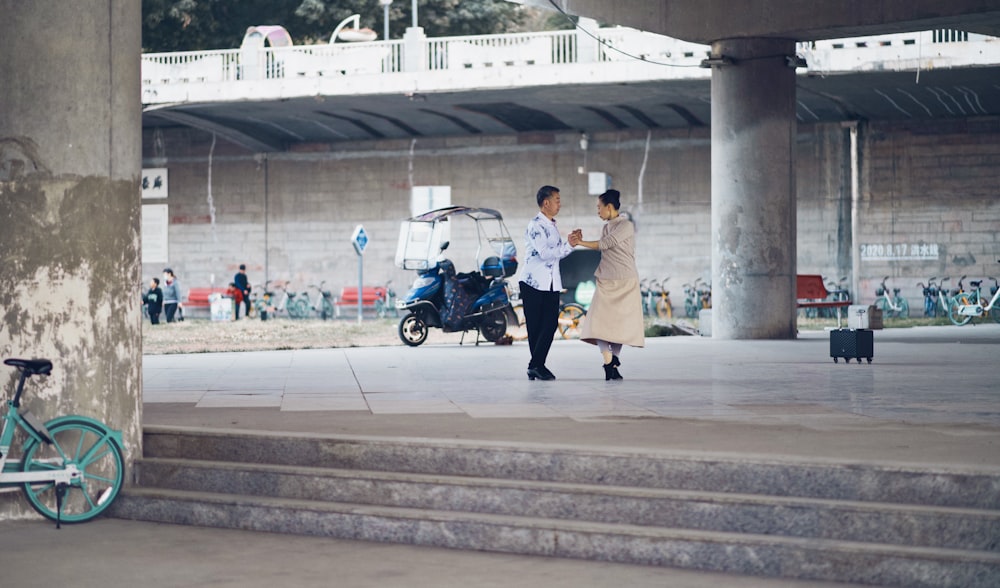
[520,186,580,380]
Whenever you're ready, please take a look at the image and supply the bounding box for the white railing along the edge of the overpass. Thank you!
[142,27,1000,103]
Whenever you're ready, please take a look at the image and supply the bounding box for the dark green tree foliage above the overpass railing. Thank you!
[142,0,526,53]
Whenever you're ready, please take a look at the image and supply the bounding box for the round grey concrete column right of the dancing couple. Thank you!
[712,39,796,339]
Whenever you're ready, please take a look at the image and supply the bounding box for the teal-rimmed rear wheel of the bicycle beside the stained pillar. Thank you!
[23,419,125,523]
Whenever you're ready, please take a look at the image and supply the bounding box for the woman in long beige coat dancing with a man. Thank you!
[578,190,645,380]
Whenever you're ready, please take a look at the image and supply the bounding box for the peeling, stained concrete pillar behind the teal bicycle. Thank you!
[0,0,142,519]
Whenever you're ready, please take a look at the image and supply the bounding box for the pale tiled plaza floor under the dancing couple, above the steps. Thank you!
[143,323,1000,466]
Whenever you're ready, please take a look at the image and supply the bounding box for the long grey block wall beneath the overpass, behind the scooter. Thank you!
[143,119,1000,311]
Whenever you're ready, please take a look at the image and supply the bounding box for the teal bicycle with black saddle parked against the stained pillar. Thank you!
[0,359,125,528]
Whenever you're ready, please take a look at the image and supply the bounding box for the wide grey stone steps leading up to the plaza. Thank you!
[111,427,1000,588]
